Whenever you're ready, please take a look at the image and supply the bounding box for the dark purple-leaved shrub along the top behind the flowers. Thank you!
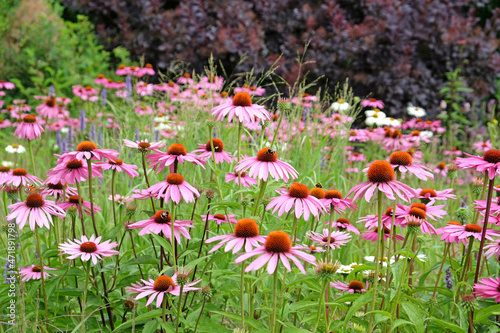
[66,0,500,115]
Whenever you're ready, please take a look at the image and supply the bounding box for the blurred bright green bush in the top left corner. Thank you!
[0,0,129,104]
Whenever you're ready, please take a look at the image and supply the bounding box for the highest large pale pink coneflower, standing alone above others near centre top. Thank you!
[210,92,271,123]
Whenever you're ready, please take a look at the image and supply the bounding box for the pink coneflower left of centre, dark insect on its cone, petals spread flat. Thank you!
[128,210,194,243]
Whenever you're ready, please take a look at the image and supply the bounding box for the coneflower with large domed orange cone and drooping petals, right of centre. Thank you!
[347,161,416,202]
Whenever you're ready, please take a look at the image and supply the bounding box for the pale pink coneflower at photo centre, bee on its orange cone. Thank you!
[235,148,299,183]
